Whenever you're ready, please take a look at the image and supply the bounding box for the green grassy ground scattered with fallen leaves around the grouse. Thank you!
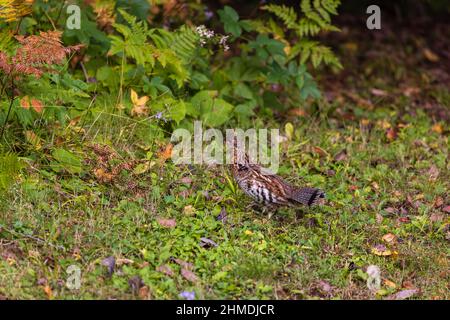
[0,19,450,299]
